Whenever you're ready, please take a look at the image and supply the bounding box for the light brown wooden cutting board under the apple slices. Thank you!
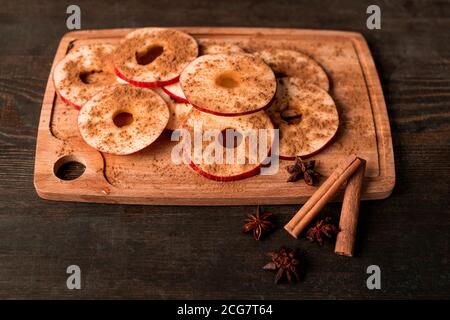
[34,27,395,205]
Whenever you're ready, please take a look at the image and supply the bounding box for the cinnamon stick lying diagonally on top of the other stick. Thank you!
[284,155,361,238]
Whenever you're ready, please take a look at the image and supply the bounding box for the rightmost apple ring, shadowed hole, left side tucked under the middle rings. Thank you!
[267,78,339,160]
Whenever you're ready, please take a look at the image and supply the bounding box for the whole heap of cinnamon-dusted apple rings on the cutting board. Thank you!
[53,28,339,181]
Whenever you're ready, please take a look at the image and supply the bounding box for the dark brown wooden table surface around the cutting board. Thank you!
[0,0,450,299]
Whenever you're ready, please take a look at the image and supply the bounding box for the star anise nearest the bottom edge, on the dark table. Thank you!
[263,247,300,284]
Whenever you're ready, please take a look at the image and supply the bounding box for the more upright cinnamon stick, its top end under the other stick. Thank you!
[334,160,366,257]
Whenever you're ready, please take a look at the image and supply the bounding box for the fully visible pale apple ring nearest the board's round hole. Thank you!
[78,84,169,155]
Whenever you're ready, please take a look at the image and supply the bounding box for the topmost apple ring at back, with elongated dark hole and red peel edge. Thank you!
[114,28,198,88]
